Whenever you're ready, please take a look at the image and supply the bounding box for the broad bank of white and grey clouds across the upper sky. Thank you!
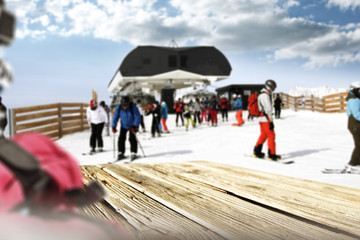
[4,0,360,68]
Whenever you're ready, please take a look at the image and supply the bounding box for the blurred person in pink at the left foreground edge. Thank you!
[0,0,133,240]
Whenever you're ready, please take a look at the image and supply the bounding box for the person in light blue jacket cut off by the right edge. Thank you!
[345,82,360,173]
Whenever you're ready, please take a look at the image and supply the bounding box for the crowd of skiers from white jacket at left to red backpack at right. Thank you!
[83,80,281,160]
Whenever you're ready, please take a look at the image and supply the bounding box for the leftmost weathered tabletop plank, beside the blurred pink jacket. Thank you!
[83,166,223,240]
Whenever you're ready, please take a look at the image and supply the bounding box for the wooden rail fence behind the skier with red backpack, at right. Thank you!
[279,92,348,113]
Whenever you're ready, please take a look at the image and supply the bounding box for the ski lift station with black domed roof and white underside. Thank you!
[108,46,232,110]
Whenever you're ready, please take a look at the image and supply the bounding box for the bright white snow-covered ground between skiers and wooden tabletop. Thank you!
[57,110,360,188]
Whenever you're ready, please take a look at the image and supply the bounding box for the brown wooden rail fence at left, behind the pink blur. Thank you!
[9,103,89,140]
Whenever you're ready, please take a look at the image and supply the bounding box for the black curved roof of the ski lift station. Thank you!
[119,46,231,76]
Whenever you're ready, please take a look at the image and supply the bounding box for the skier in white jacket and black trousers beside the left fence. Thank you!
[86,99,107,154]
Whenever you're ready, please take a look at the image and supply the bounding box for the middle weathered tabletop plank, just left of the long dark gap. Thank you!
[92,164,358,239]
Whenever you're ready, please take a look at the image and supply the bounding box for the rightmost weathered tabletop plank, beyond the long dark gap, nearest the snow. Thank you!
[181,162,360,236]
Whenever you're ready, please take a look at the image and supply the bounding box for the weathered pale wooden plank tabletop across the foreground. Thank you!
[82,161,360,240]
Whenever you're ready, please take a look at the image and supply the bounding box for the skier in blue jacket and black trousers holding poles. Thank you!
[112,96,140,160]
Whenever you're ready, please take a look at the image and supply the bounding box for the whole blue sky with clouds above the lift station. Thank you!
[3,0,360,107]
